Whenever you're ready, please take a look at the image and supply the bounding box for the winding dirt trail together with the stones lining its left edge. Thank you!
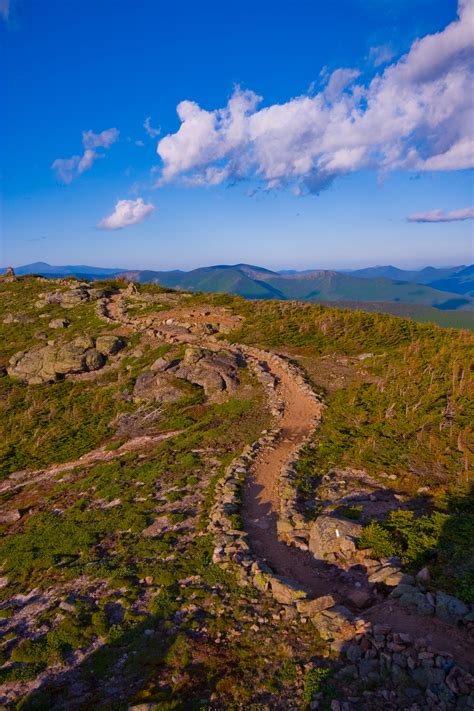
[101,295,474,672]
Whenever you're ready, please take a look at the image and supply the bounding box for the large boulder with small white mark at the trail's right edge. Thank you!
[309,514,363,560]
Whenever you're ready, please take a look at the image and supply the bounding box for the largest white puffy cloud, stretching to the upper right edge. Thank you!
[157,0,474,194]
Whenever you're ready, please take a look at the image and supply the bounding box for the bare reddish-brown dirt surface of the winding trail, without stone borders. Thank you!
[103,297,474,672]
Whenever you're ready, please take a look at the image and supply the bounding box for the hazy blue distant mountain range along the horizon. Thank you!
[3,262,474,310]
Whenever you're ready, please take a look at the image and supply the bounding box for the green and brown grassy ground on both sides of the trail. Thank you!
[0,276,474,711]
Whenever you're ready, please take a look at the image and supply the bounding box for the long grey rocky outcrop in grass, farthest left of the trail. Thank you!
[7,336,124,385]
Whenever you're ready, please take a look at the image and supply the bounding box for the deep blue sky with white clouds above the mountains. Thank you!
[0,0,474,269]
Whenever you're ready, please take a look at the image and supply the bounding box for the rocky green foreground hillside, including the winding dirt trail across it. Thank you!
[0,272,474,711]
